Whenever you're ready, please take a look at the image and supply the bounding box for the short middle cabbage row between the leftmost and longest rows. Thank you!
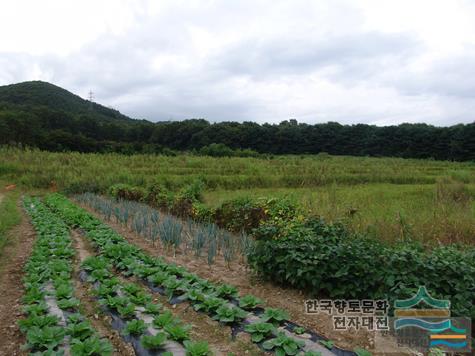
[81,256,211,356]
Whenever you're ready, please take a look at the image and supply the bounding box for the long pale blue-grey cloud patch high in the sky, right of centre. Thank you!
[212,32,418,80]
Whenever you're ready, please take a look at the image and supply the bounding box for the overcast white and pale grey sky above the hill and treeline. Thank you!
[0,0,475,126]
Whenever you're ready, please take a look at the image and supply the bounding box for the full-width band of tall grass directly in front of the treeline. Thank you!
[0,148,475,192]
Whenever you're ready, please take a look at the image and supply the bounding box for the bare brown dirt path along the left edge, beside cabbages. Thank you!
[0,200,35,356]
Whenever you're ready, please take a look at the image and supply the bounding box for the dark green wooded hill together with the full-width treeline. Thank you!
[0,81,475,161]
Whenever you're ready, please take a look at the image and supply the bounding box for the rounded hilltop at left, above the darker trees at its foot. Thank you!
[0,81,131,120]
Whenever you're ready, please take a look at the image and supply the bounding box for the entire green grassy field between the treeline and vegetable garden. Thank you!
[0,149,475,243]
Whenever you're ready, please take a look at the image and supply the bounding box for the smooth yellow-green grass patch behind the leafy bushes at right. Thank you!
[204,182,475,244]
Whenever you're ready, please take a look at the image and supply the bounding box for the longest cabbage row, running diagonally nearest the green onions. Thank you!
[46,194,353,356]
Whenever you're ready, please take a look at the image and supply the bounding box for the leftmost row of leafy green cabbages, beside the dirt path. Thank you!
[19,198,112,356]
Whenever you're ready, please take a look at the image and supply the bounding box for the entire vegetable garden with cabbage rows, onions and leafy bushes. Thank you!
[5,179,475,356]
